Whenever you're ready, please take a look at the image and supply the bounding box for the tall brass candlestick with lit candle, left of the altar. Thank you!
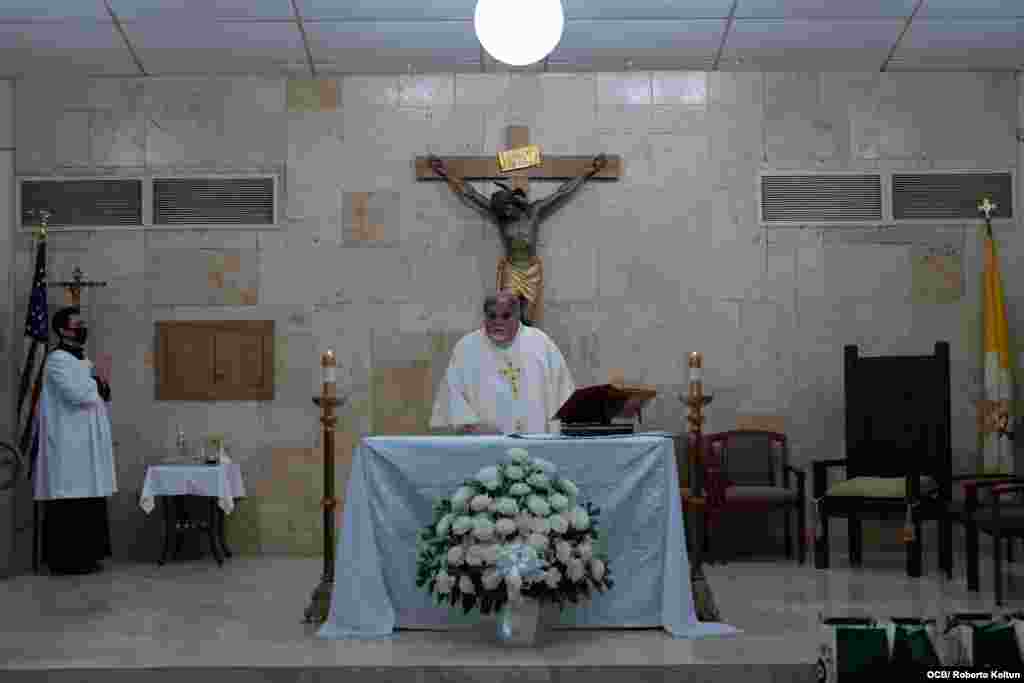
[304,349,345,625]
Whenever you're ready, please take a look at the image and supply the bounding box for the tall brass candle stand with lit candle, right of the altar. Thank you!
[680,351,721,622]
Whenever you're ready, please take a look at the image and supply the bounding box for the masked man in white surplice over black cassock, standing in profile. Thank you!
[34,307,118,574]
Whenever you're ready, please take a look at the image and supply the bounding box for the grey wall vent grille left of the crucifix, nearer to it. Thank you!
[153,177,274,225]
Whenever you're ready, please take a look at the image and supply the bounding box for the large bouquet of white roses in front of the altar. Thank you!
[416,449,614,614]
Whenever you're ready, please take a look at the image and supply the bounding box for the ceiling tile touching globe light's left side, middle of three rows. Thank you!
[303,22,480,57]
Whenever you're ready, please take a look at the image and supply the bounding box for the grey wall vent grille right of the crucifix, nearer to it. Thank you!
[761,174,882,224]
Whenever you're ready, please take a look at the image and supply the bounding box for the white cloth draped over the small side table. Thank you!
[138,463,246,514]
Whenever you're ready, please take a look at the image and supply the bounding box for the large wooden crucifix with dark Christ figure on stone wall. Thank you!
[416,126,623,325]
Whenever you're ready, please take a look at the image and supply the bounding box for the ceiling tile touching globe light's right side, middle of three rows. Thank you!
[558,19,725,52]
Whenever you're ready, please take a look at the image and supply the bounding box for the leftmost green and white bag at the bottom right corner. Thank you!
[817,617,892,683]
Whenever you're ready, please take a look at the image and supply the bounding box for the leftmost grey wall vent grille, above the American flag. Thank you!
[22,179,142,227]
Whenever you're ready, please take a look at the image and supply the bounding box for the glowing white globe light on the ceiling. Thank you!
[473,0,565,67]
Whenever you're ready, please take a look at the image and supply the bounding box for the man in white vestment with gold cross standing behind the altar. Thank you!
[430,291,575,434]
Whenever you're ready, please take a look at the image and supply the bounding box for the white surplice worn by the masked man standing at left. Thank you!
[33,350,118,501]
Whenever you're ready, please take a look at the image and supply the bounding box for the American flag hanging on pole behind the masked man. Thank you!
[15,239,50,475]
